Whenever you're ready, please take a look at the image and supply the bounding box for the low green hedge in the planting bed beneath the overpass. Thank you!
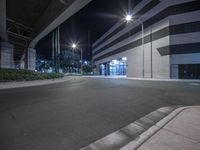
[0,69,64,81]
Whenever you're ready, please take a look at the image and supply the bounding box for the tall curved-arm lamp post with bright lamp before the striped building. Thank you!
[125,14,144,78]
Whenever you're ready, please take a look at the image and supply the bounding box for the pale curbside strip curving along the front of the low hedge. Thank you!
[0,76,78,90]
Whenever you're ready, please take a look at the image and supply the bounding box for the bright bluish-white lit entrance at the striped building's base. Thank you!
[99,57,127,76]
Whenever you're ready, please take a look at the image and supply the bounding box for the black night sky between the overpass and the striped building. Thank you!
[36,0,128,60]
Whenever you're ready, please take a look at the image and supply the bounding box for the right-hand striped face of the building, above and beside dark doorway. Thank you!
[170,10,200,78]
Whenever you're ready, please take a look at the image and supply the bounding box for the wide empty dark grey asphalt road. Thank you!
[0,78,200,150]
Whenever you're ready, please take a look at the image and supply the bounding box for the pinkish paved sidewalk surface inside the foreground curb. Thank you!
[138,107,200,150]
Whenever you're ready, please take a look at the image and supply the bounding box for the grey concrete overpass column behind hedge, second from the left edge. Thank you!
[27,48,36,71]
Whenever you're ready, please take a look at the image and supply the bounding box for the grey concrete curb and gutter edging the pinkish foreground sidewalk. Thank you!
[80,106,190,150]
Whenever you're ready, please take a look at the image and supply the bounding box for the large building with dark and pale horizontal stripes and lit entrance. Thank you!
[92,0,200,79]
